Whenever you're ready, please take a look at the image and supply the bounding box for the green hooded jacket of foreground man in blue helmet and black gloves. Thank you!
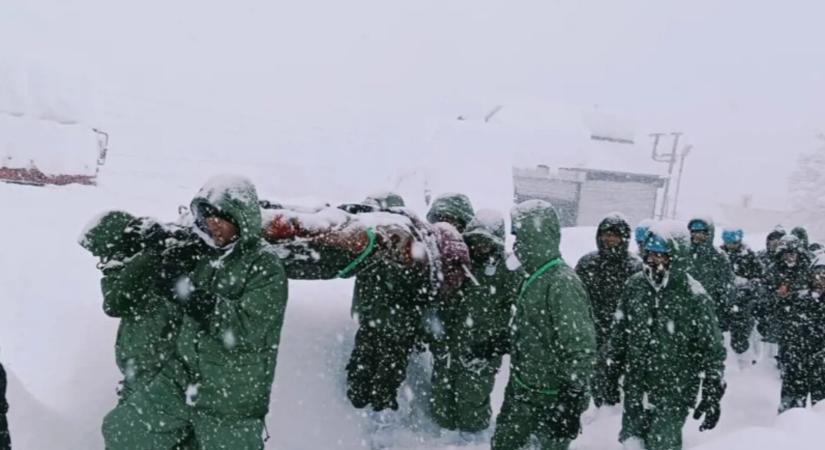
[605,231,725,428]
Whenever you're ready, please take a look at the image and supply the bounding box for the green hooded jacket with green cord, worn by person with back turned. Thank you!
[510,200,596,393]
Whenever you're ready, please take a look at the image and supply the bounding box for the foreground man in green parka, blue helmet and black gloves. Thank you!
[601,229,725,450]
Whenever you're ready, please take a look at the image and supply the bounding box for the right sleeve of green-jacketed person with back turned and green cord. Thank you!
[545,271,596,390]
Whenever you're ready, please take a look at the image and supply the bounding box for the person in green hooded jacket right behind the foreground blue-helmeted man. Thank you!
[688,219,735,331]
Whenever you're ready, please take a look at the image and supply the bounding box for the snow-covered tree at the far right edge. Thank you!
[790,134,825,240]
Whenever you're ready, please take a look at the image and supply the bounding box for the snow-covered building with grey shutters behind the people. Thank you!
[416,100,667,226]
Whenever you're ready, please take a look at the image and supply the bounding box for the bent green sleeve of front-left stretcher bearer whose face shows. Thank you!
[210,253,288,352]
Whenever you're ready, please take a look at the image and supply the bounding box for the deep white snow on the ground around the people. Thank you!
[0,155,825,450]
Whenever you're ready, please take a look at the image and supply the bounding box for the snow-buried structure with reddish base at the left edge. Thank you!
[0,58,108,184]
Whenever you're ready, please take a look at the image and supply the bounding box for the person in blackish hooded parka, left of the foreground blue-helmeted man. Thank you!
[576,214,646,406]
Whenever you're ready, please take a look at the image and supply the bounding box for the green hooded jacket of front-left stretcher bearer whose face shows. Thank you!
[177,177,287,419]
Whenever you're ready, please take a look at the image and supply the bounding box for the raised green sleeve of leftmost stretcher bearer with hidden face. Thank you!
[100,252,160,317]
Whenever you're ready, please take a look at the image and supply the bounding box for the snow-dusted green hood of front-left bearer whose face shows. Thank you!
[191,176,262,247]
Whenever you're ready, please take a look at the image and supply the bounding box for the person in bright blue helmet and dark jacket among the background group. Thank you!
[720,229,765,354]
